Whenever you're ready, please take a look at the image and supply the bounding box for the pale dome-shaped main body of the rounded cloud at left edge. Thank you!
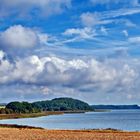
[0,25,38,48]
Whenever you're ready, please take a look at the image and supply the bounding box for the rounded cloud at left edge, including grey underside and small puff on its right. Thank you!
[0,25,49,54]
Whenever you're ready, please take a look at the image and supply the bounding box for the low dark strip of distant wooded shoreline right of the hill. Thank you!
[91,105,140,110]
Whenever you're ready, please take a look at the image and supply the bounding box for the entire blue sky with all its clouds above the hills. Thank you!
[0,0,140,104]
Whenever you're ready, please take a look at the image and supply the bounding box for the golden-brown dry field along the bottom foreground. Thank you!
[0,128,140,140]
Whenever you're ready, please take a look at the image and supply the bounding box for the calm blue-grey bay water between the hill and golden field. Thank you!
[0,110,140,131]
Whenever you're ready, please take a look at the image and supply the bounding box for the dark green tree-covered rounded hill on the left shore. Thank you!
[6,98,93,113]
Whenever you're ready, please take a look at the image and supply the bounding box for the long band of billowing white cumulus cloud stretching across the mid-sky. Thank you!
[0,50,136,89]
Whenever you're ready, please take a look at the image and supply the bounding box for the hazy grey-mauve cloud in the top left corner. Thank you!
[0,0,71,17]
